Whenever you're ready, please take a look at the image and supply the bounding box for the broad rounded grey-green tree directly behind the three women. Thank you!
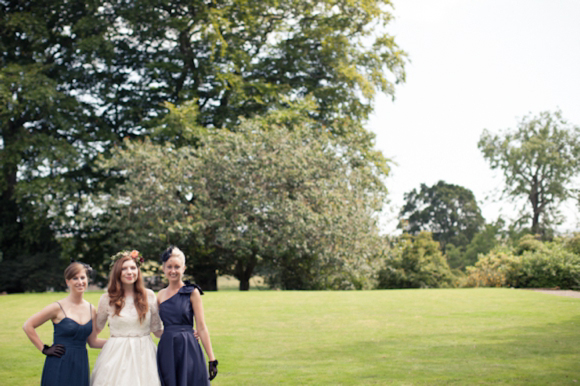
[87,105,386,290]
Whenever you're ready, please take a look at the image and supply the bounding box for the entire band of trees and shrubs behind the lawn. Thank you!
[0,0,580,293]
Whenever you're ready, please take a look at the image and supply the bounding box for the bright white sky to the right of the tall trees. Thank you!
[367,0,580,232]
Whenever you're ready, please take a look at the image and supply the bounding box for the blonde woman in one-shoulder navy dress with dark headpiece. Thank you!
[157,247,218,386]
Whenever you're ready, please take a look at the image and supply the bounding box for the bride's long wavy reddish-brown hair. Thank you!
[108,252,149,323]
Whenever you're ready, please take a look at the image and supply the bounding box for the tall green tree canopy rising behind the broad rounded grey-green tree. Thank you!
[0,0,406,291]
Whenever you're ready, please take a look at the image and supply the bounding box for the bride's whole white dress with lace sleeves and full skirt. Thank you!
[91,290,163,386]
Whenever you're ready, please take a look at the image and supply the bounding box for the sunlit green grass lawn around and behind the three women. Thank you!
[0,289,580,385]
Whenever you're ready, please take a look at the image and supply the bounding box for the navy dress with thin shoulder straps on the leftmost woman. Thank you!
[40,302,93,386]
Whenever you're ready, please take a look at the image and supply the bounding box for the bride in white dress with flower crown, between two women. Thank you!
[91,251,163,386]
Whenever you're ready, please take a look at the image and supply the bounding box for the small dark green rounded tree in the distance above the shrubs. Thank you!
[399,181,484,250]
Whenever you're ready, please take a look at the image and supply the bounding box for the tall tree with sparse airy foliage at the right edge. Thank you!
[478,111,580,236]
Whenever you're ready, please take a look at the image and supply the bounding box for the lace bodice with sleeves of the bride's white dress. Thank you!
[97,290,163,338]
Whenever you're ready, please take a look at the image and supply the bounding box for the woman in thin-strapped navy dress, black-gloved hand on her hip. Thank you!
[22,262,106,386]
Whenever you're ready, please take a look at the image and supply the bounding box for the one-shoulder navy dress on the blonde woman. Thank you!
[157,283,210,386]
